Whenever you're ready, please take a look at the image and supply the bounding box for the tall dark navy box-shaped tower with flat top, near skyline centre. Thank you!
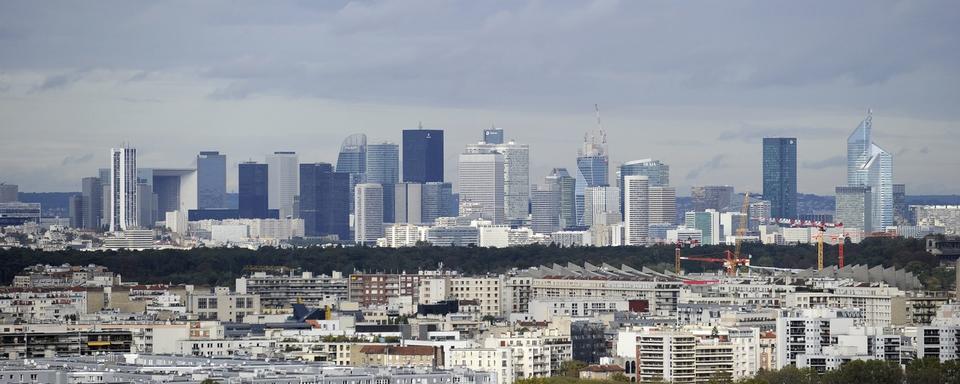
[403,126,443,183]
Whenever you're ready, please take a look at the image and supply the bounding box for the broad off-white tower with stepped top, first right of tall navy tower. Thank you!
[458,152,504,224]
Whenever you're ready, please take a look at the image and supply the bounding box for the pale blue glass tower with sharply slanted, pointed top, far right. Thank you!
[847,112,894,231]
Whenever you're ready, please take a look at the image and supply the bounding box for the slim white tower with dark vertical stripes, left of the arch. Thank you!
[110,147,137,232]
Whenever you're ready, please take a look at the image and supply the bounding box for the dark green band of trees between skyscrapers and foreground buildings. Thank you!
[0,238,953,289]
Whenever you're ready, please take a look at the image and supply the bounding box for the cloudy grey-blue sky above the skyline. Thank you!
[0,0,960,195]
